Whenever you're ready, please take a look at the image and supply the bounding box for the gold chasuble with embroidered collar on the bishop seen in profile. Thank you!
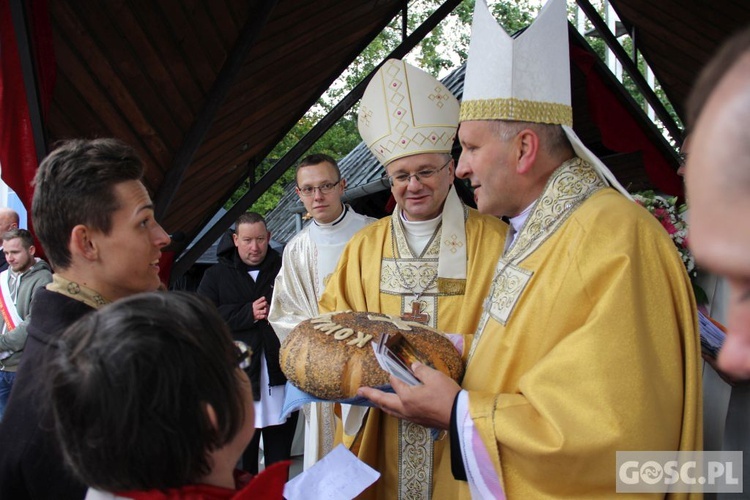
[436,159,702,499]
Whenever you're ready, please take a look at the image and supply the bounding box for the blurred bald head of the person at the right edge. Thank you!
[685,29,750,379]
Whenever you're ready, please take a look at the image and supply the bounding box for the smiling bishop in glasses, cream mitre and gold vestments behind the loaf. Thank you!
[320,60,507,498]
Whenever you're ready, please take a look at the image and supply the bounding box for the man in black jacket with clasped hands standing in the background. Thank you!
[198,212,298,474]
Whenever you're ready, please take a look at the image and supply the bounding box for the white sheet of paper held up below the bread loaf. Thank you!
[284,444,380,500]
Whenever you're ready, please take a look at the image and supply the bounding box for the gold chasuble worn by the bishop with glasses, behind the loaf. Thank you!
[320,205,507,500]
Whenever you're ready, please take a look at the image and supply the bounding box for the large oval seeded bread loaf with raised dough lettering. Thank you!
[280,311,464,399]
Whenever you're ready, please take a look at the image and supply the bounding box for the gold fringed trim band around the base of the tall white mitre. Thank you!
[458,97,573,127]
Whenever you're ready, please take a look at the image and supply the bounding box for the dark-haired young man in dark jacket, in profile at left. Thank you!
[0,139,170,500]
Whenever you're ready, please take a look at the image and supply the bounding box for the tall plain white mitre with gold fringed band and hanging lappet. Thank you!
[460,0,630,198]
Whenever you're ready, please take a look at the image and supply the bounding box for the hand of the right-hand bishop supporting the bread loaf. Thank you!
[357,363,461,430]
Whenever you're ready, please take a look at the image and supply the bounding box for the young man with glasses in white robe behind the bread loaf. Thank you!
[268,154,375,469]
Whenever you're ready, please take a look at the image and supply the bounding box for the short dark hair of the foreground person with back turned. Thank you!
[47,292,249,492]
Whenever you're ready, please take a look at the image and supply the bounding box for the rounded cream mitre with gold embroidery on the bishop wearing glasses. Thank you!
[357,59,459,166]
